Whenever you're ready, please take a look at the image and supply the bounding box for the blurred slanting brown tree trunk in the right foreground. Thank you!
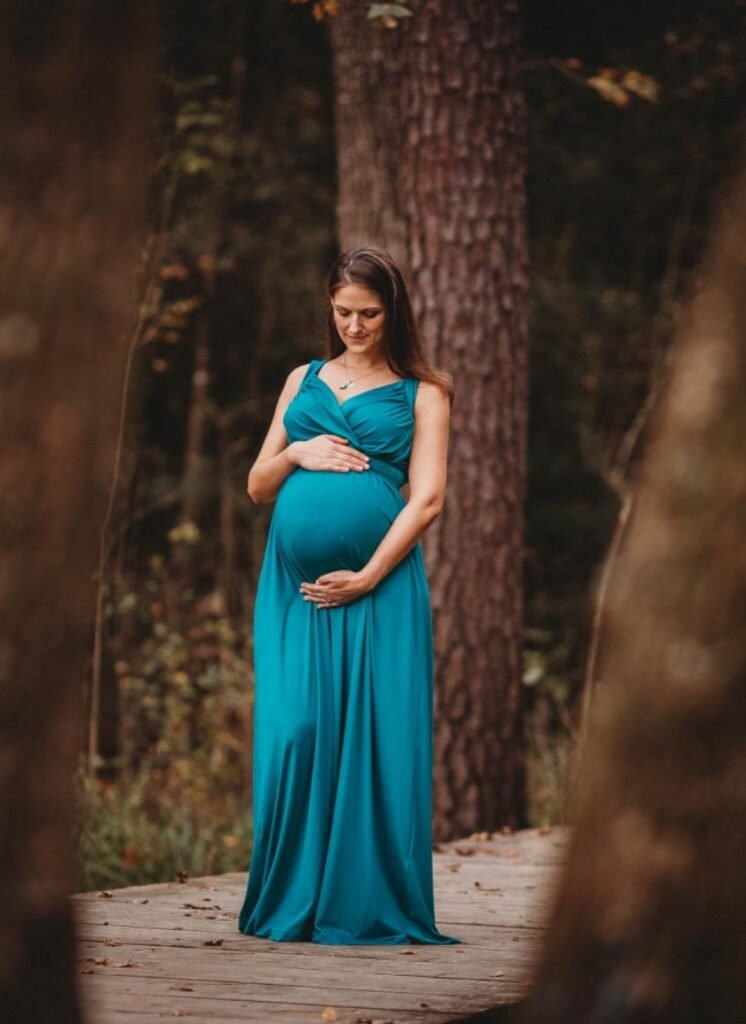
[526,163,746,1024]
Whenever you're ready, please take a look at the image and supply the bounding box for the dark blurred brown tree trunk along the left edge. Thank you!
[0,0,152,1024]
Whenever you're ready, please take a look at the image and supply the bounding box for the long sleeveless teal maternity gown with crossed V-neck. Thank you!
[238,359,462,945]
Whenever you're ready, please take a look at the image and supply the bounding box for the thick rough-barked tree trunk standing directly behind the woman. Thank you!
[332,0,527,839]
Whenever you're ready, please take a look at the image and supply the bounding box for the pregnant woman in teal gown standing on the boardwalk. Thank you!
[238,247,462,945]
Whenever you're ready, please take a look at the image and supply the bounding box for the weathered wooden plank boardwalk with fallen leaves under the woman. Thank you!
[73,829,568,1024]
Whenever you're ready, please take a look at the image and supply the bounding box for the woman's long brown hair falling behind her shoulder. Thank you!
[326,246,453,401]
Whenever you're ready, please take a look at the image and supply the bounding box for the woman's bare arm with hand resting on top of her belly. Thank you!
[247,364,368,503]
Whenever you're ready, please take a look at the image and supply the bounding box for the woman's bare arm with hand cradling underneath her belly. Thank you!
[301,381,450,606]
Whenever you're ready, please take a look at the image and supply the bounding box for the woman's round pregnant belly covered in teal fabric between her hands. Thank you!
[272,468,404,584]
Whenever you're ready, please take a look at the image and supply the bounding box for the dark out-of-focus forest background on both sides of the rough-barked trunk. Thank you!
[69,0,746,889]
